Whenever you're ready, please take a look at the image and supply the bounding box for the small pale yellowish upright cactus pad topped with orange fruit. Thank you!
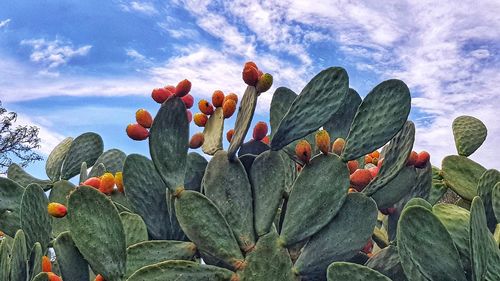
[201,107,224,155]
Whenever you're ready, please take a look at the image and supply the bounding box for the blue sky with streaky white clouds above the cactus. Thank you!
[0,0,500,178]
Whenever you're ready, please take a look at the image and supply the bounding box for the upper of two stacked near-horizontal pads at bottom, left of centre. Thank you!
[125,240,196,279]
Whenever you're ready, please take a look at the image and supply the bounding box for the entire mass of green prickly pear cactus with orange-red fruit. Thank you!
[0,62,500,281]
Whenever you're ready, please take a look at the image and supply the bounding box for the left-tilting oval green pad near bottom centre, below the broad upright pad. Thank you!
[175,190,243,265]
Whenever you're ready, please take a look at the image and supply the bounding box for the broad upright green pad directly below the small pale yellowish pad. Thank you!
[203,150,255,250]
